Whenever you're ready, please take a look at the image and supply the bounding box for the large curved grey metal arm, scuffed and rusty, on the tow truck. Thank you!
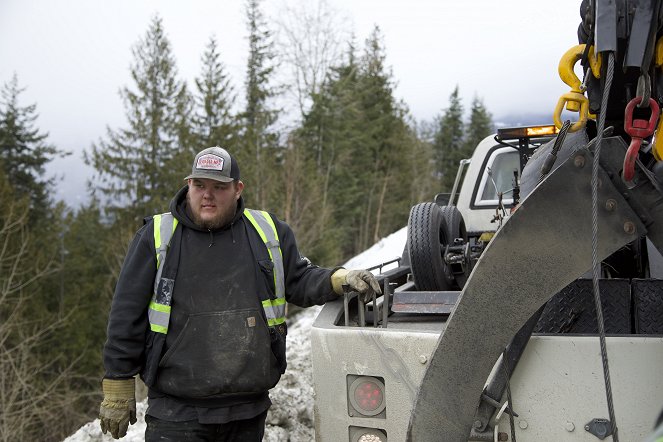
[408,148,646,442]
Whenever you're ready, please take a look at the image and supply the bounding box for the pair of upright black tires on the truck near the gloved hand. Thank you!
[407,203,467,291]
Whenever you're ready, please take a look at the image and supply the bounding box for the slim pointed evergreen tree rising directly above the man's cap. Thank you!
[194,37,239,152]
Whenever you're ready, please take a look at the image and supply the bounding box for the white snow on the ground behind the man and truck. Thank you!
[64,227,407,442]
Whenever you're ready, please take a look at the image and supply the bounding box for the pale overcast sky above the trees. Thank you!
[0,0,580,204]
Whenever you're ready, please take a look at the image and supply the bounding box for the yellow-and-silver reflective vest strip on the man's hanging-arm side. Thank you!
[147,212,177,333]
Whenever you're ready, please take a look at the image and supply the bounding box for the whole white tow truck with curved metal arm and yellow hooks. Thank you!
[311,0,663,442]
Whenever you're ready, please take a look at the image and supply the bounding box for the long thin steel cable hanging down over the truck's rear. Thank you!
[592,52,619,442]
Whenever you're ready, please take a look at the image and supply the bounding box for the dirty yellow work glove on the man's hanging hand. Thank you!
[99,378,136,439]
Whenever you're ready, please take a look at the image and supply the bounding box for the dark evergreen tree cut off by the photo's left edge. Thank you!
[0,74,67,220]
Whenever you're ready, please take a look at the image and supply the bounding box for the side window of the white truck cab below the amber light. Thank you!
[474,147,520,206]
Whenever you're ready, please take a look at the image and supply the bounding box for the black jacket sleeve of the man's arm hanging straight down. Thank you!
[103,222,156,378]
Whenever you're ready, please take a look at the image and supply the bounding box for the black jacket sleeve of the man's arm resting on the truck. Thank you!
[272,215,338,307]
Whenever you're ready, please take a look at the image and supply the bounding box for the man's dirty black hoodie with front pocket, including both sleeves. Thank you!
[104,186,337,407]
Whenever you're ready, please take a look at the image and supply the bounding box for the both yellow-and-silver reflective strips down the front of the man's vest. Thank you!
[148,209,286,334]
